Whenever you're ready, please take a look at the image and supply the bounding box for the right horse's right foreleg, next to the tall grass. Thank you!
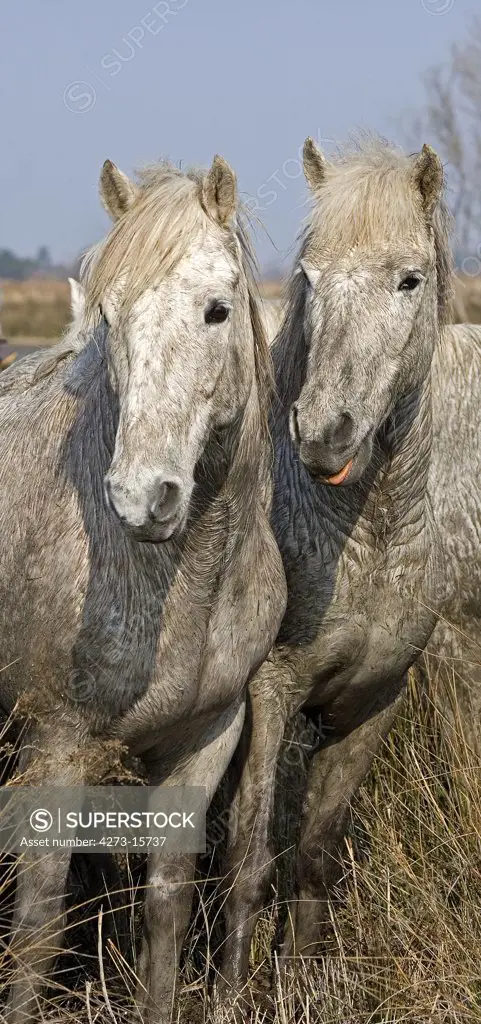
[281,688,404,957]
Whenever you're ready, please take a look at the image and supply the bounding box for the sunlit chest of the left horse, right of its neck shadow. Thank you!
[117,524,285,753]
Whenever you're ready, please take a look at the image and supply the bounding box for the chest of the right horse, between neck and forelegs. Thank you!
[279,516,435,710]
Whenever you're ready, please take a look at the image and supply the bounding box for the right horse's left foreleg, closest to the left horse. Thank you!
[217,662,287,1006]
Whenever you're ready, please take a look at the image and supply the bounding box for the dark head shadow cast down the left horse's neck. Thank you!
[60,328,247,731]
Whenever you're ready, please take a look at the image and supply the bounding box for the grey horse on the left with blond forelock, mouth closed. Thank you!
[0,157,286,1024]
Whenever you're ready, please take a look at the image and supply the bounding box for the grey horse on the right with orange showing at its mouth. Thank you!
[215,139,451,1000]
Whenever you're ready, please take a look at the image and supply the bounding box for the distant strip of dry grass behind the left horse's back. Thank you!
[0,278,70,341]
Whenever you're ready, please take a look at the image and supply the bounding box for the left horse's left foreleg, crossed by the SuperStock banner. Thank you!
[7,726,83,1024]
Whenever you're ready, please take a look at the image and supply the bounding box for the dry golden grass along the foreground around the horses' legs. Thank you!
[0,667,481,1024]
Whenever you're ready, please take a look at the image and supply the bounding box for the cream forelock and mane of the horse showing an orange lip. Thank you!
[299,133,453,328]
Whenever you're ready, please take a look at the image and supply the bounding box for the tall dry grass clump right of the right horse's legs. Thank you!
[325,681,481,1024]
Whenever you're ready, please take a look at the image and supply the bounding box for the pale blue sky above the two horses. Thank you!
[0,0,477,265]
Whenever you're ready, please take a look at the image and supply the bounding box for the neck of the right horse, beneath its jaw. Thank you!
[272,317,433,548]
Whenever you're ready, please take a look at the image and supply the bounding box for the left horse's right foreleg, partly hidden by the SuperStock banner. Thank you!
[137,695,245,1024]
